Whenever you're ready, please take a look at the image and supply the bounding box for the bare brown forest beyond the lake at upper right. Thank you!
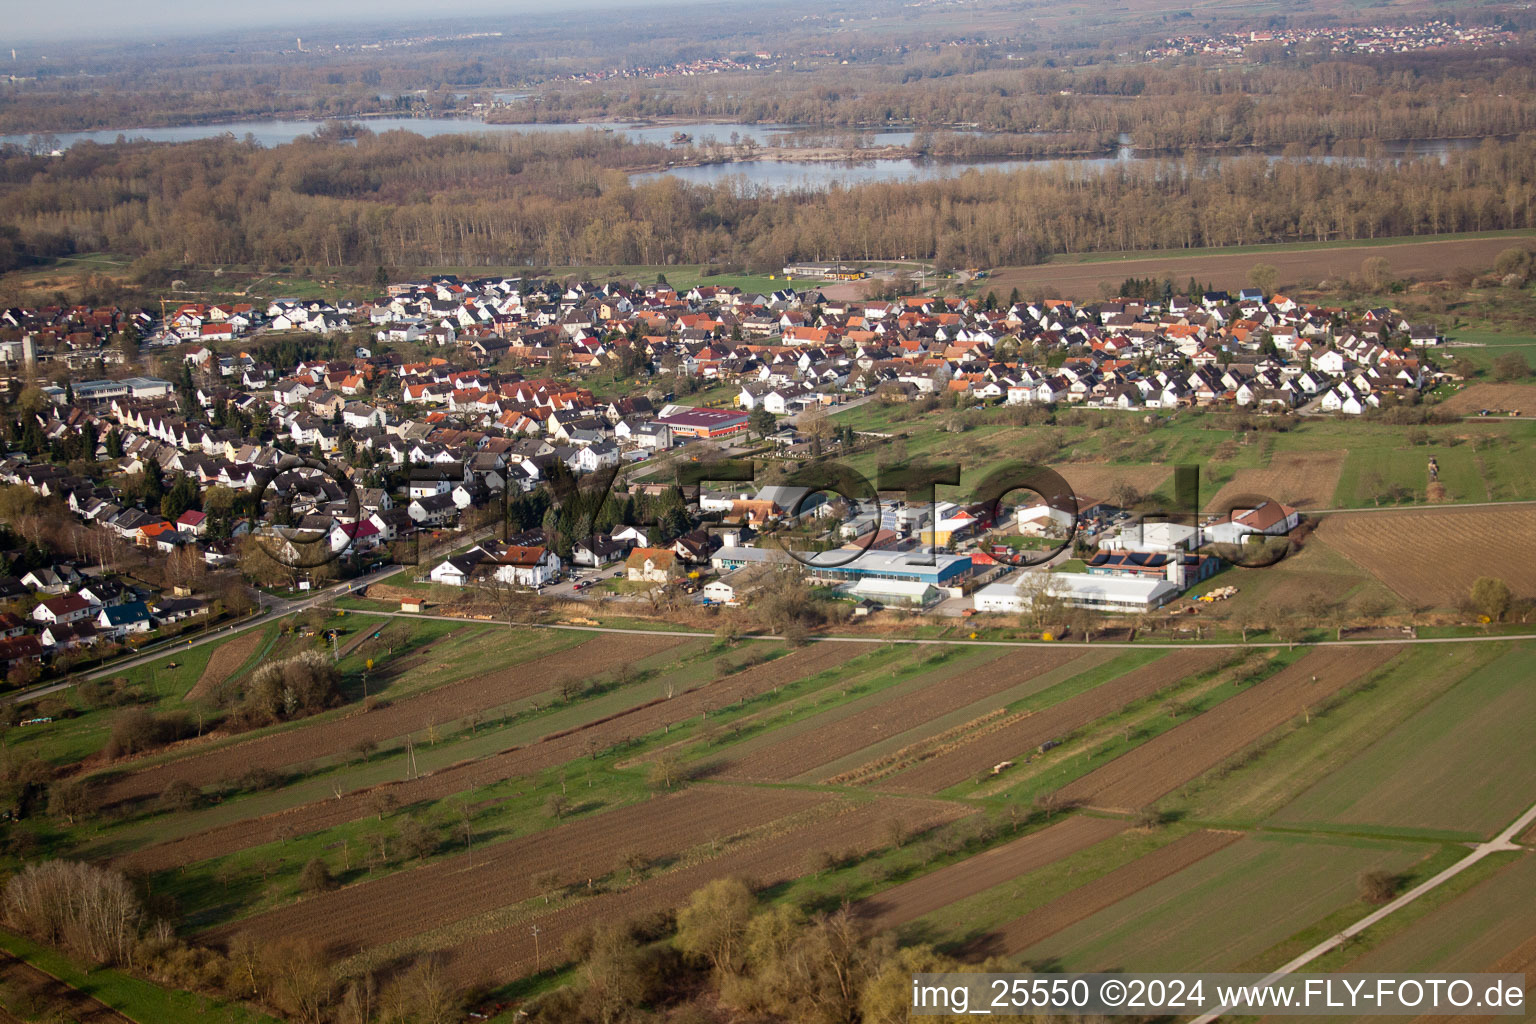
[492,48,1536,150]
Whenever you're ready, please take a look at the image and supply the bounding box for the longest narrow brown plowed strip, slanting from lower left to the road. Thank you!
[117,636,869,870]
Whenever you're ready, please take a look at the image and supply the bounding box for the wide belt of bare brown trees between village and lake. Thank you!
[0,125,1536,274]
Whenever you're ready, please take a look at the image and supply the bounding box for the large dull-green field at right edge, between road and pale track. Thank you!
[1272,645,1536,838]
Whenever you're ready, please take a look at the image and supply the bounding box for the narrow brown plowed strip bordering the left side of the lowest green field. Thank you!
[965,829,1243,961]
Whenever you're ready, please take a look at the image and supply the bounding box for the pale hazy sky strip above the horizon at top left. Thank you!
[0,0,678,42]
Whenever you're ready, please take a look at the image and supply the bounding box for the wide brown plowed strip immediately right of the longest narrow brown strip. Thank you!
[714,648,1080,780]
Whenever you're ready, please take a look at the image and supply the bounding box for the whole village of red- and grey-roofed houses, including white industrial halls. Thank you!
[0,276,1445,683]
